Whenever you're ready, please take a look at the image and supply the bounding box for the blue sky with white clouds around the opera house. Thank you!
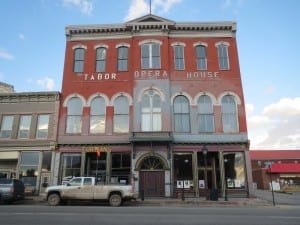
[0,0,300,150]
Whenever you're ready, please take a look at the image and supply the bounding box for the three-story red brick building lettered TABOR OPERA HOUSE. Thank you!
[54,14,253,197]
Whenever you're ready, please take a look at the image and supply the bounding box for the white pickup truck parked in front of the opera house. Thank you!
[45,177,137,206]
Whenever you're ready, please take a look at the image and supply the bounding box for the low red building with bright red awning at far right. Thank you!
[250,150,300,189]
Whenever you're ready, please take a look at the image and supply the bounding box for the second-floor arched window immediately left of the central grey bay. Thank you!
[114,96,129,133]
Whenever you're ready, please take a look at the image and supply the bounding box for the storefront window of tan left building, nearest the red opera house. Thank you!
[20,152,39,193]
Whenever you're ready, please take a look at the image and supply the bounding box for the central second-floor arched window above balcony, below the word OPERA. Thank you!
[141,89,161,131]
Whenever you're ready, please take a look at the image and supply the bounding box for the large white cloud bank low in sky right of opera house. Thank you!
[247,97,300,149]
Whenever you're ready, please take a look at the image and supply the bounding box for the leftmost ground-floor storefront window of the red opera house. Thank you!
[62,154,81,180]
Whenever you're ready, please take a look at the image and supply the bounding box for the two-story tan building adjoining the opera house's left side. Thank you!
[0,92,59,193]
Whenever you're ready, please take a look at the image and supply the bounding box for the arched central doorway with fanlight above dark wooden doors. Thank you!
[137,155,167,197]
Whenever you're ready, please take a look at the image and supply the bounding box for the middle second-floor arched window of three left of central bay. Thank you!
[90,96,106,134]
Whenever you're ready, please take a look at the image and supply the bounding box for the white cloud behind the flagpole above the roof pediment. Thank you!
[125,0,182,21]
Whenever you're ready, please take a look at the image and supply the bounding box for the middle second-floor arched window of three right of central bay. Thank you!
[198,95,214,132]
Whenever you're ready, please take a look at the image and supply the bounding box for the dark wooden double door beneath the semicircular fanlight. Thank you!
[139,170,165,197]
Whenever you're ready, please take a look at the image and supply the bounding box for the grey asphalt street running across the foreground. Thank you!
[0,205,300,225]
